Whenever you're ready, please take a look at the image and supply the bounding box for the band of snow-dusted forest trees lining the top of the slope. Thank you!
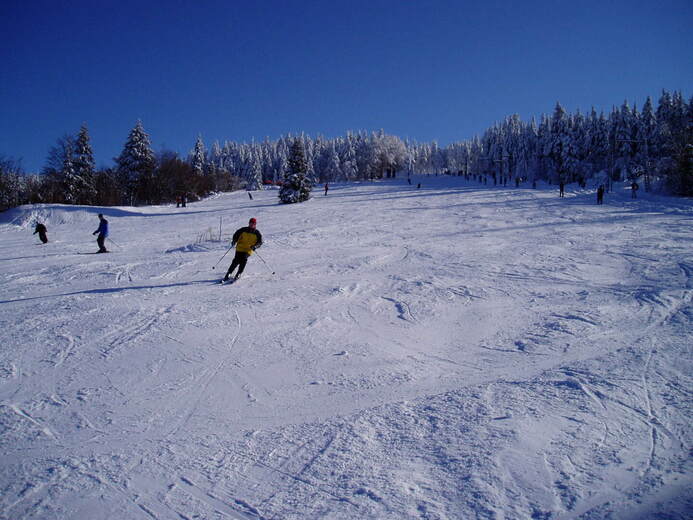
[0,90,693,210]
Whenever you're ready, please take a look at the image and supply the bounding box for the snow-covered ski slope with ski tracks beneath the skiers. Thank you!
[0,176,693,520]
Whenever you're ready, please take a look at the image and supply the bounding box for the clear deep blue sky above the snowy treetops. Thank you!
[0,0,693,175]
